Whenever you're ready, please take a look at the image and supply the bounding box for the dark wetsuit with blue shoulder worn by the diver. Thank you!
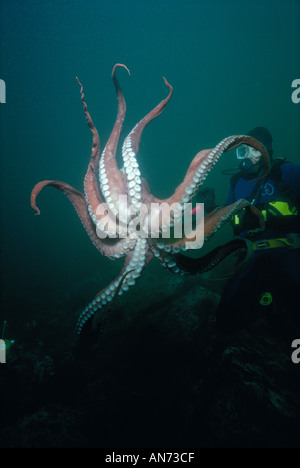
[217,163,300,332]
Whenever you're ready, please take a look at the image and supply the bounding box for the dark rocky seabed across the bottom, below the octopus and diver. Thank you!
[0,276,300,448]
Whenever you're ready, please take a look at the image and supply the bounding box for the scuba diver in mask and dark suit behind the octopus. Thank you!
[217,127,300,332]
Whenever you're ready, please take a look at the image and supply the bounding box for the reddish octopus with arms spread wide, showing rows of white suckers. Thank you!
[31,64,269,334]
